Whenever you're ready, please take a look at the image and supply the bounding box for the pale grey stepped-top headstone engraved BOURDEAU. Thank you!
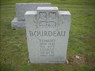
[25,7,71,63]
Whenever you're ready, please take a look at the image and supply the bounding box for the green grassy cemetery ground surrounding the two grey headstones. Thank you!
[0,0,95,71]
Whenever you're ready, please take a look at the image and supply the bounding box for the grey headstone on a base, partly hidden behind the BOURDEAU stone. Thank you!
[11,3,51,29]
